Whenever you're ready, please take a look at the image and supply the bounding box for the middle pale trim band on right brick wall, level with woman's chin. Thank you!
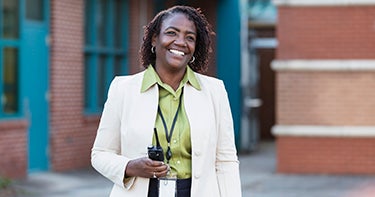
[271,59,375,71]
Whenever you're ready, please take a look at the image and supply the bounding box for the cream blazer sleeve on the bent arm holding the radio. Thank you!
[91,77,134,189]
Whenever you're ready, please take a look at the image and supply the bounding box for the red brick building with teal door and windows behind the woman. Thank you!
[0,0,247,178]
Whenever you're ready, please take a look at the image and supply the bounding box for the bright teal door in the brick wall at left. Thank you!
[21,0,49,172]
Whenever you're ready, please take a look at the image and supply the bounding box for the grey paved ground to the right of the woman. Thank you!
[240,143,375,197]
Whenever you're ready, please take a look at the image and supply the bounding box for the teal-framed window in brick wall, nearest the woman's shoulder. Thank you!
[84,0,128,114]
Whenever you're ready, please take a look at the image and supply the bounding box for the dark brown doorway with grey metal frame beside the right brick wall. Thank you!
[242,33,277,151]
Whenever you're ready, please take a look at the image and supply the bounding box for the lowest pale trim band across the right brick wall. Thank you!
[272,125,375,137]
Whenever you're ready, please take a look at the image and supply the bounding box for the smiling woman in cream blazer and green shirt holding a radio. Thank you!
[91,6,241,197]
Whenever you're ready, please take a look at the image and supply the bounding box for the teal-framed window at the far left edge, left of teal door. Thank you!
[0,0,20,117]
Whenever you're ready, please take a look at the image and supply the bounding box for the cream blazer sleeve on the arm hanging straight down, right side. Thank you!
[216,81,242,197]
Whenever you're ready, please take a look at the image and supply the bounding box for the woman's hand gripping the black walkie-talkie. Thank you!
[125,157,169,178]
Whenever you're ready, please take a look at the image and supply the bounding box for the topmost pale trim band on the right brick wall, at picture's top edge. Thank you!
[273,0,375,6]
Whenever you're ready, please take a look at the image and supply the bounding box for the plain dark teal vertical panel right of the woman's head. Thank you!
[216,0,241,147]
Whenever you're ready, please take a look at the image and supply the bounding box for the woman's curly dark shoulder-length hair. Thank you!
[140,5,215,73]
